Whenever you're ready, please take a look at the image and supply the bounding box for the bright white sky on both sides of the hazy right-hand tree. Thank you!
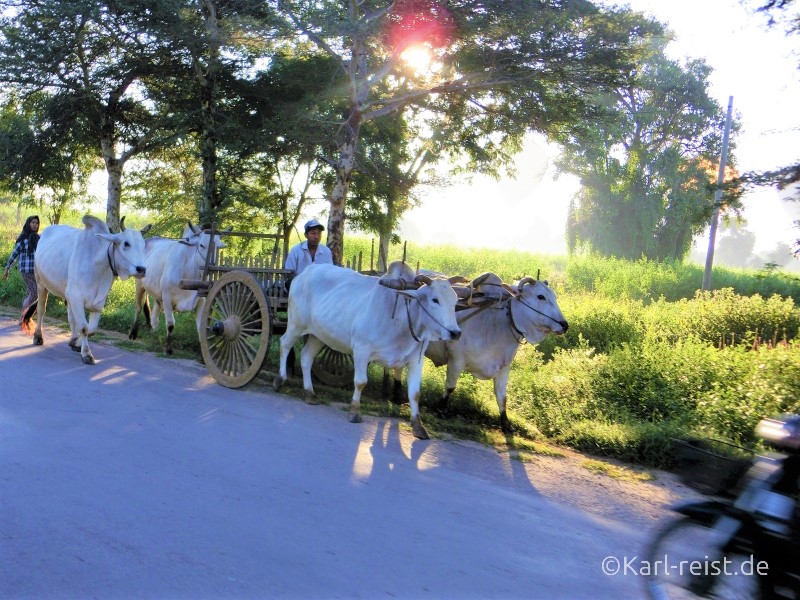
[400,0,800,254]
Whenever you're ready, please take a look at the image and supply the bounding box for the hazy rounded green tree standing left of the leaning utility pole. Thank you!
[556,31,733,260]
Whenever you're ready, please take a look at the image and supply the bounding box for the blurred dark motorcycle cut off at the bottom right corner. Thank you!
[642,415,800,600]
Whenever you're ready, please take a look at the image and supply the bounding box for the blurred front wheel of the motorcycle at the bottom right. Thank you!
[643,516,766,600]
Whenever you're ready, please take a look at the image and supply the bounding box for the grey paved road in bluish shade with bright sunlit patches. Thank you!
[0,318,643,600]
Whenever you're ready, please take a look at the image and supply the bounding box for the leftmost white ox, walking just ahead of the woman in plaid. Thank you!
[27,215,150,365]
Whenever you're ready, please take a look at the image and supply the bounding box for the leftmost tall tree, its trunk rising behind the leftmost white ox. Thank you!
[0,0,180,230]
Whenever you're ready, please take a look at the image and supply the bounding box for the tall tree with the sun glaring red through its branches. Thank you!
[278,0,656,262]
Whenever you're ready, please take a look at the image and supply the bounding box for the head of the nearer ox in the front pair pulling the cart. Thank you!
[389,275,461,341]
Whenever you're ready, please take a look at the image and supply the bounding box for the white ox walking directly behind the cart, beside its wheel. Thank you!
[128,222,226,354]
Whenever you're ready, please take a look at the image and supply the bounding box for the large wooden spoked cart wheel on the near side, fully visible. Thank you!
[200,270,272,388]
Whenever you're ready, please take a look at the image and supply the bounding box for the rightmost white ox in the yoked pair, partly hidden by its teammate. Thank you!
[424,274,568,433]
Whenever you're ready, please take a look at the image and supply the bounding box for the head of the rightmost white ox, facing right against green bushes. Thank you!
[509,277,569,344]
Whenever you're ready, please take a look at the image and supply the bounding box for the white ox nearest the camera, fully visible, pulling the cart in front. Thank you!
[273,264,461,439]
